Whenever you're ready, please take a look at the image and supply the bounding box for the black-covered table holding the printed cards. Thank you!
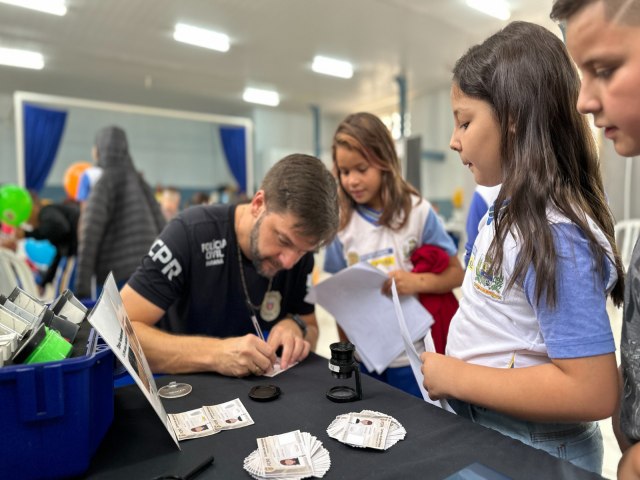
[86,354,601,480]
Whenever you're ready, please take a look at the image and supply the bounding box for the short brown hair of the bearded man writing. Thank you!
[260,153,339,246]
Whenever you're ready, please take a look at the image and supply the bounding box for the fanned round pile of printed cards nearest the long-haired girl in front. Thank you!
[327,410,407,450]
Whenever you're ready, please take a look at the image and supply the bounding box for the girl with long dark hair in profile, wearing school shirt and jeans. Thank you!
[422,22,623,473]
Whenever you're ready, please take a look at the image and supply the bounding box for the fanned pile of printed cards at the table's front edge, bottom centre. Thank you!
[244,430,331,480]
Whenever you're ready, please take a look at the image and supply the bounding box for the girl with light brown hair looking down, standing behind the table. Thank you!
[324,113,464,398]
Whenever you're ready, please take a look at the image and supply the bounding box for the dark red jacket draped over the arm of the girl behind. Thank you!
[411,245,458,353]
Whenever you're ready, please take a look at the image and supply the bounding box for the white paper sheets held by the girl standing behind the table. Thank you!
[306,262,433,373]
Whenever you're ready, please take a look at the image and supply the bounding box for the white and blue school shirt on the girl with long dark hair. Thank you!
[447,205,617,368]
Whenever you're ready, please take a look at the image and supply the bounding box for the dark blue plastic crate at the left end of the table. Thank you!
[0,330,114,479]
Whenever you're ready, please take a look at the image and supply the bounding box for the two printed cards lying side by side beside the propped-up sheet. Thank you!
[168,398,254,440]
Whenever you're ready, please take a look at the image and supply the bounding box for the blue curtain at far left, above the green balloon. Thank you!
[23,104,67,192]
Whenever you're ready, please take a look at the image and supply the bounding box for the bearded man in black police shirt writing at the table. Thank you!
[121,154,338,377]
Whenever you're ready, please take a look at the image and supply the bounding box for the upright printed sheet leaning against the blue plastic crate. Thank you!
[87,273,180,449]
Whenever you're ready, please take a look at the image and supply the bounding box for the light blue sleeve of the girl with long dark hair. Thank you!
[524,224,615,359]
